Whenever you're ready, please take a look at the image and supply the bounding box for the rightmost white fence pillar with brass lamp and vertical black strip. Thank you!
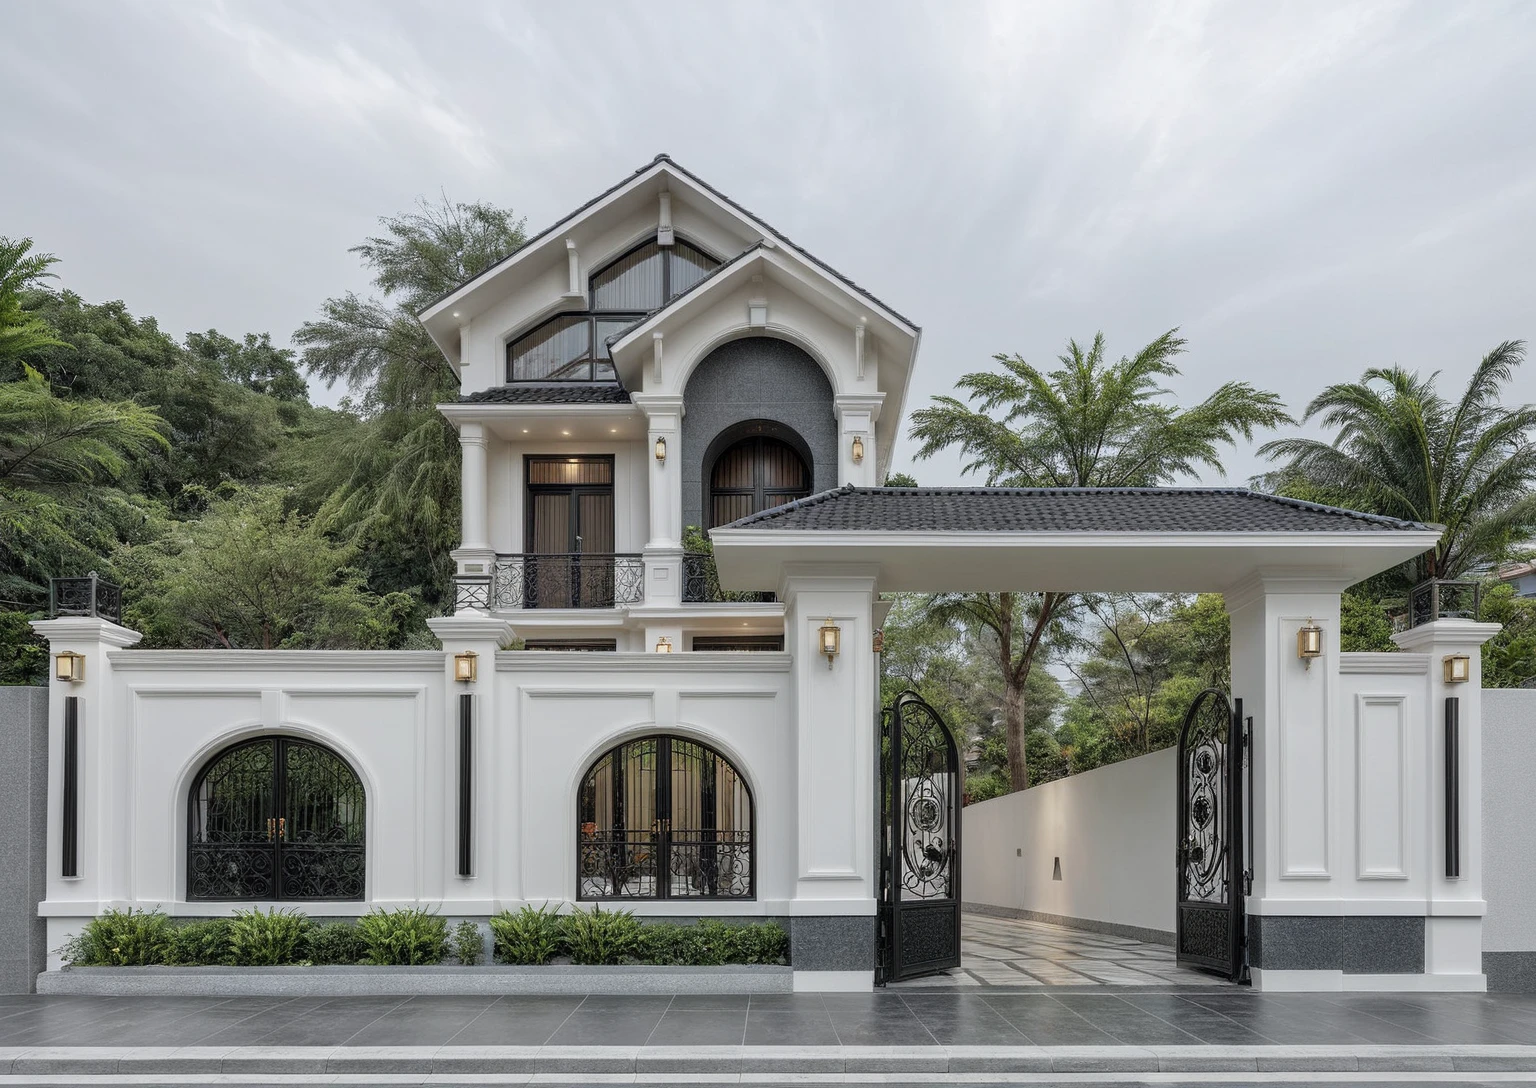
[1392,619,1499,990]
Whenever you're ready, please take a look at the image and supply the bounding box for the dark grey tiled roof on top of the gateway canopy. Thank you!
[722,486,1441,533]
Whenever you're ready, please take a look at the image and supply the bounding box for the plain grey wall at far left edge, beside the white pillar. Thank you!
[0,687,48,994]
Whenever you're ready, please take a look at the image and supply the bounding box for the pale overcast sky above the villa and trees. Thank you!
[0,0,1536,484]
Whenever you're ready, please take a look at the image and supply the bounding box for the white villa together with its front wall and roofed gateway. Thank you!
[27,155,1523,990]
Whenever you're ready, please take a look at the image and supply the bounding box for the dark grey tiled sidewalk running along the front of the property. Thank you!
[0,987,1536,1050]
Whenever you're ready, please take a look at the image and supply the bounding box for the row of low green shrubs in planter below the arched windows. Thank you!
[58,905,790,967]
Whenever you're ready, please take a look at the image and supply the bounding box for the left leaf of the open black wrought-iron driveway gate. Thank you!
[876,692,962,984]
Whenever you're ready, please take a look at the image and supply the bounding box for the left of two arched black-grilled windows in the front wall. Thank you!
[187,736,367,901]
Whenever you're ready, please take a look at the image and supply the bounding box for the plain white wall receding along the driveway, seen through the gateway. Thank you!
[960,748,1177,934]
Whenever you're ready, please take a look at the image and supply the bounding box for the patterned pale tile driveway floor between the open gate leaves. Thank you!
[899,913,1226,990]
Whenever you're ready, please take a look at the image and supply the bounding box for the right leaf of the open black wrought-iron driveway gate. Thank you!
[1175,688,1250,980]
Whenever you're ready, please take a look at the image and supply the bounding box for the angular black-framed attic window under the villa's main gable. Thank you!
[507,238,720,381]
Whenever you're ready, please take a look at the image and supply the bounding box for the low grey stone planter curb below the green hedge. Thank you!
[37,965,794,997]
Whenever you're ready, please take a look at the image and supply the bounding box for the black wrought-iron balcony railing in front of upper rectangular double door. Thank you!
[458,552,645,612]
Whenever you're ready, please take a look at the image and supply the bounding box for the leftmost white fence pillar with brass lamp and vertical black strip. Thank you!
[32,616,142,968]
